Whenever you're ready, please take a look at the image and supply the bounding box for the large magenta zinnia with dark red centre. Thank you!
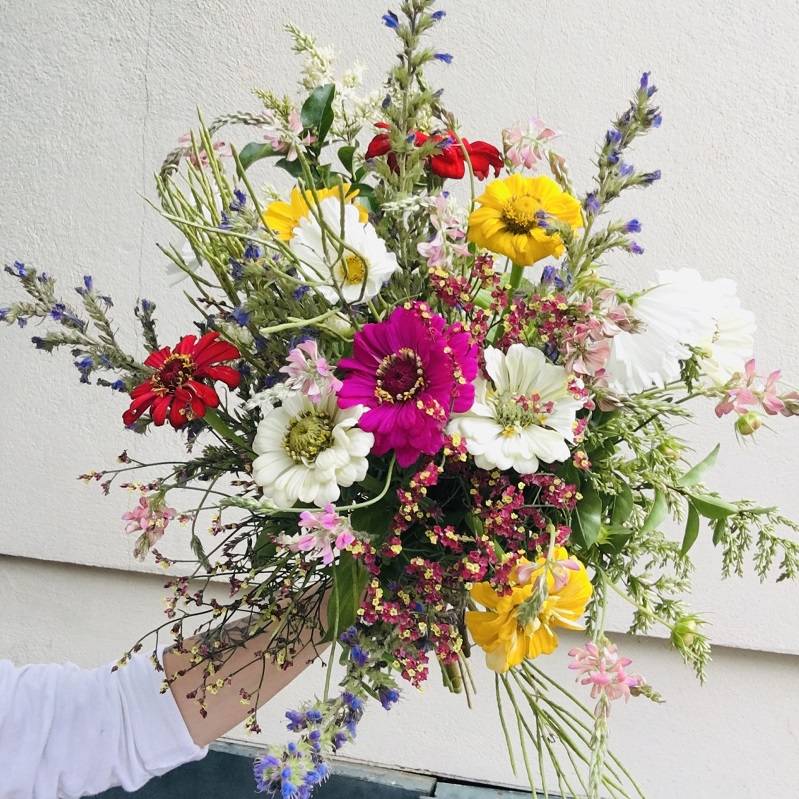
[338,303,477,466]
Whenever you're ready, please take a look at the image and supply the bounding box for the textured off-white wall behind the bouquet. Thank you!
[0,0,799,797]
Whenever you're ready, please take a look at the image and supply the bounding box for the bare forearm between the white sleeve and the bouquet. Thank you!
[164,599,327,746]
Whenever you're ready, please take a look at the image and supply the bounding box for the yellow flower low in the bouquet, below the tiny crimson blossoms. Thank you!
[466,547,593,672]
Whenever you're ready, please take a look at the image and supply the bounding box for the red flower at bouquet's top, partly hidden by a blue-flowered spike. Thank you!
[366,122,502,180]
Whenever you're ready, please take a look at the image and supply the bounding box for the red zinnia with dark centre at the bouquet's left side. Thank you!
[122,331,241,427]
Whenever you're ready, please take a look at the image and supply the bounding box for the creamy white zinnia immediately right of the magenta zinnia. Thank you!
[447,344,582,474]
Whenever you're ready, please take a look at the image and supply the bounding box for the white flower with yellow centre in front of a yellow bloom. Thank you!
[289,197,399,303]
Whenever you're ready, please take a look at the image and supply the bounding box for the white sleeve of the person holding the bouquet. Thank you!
[0,655,208,799]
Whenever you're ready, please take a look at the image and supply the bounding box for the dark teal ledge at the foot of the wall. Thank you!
[96,751,544,799]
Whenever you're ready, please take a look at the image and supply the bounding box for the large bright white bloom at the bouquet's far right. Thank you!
[605,269,754,395]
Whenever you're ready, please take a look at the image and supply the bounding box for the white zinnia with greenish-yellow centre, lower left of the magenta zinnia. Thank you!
[253,392,374,508]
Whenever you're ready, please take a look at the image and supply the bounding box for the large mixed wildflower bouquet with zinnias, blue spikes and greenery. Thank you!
[0,0,799,799]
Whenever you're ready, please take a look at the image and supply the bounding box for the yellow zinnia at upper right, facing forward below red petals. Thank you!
[468,175,582,266]
